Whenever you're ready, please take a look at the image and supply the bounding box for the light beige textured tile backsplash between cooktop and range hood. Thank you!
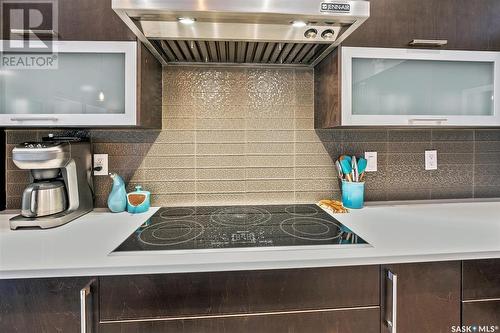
[154,67,338,204]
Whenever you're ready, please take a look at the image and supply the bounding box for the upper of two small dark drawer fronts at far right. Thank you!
[462,259,500,300]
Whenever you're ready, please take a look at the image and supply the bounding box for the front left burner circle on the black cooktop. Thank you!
[138,220,204,246]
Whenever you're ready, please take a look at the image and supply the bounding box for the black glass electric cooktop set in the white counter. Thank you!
[114,205,367,252]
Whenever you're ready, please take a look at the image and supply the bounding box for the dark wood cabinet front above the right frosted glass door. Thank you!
[343,0,500,51]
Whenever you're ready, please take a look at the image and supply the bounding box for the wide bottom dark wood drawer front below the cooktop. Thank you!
[99,308,380,333]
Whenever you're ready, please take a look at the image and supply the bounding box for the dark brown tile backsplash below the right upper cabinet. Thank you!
[318,129,500,200]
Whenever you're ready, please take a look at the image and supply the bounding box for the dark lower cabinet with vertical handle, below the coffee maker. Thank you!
[0,277,98,333]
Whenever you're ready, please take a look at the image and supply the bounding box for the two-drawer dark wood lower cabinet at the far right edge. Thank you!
[462,259,500,326]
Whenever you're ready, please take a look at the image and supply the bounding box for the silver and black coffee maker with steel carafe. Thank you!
[10,135,94,229]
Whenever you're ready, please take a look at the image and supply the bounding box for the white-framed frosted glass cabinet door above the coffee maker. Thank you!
[0,42,136,127]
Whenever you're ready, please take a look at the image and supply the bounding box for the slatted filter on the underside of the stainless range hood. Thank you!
[152,40,328,66]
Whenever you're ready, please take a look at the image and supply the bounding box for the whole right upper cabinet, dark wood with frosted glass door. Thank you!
[314,0,500,128]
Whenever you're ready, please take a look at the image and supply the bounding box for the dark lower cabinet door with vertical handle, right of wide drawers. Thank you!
[381,261,461,333]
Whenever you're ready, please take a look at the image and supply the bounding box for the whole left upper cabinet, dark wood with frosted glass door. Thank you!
[0,0,162,128]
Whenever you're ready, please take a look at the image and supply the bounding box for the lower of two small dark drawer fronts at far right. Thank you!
[462,301,500,326]
